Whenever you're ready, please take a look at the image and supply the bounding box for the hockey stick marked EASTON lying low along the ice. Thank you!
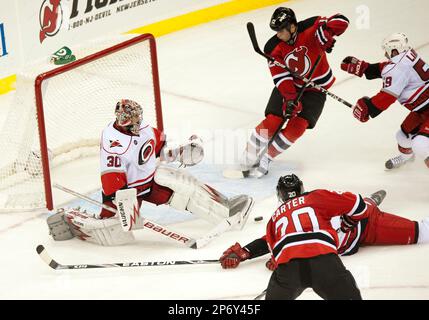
[36,244,219,270]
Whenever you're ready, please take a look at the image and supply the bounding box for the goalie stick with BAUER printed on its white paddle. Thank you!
[52,183,224,249]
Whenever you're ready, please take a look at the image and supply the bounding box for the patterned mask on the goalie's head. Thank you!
[115,99,143,135]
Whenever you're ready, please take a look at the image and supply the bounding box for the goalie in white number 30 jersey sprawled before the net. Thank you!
[47,99,253,246]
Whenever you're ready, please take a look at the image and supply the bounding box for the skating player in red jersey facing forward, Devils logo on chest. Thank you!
[241,7,349,177]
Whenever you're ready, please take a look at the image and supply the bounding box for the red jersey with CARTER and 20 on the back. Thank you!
[266,190,367,264]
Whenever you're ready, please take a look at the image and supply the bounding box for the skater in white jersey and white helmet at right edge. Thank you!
[341,33,429,169]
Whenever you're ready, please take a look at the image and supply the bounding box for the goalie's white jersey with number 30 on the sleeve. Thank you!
[100,122,164,195]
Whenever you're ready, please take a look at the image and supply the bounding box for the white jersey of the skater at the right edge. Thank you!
[381,49,429,112]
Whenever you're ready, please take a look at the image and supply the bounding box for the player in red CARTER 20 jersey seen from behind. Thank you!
[220,174,362,299]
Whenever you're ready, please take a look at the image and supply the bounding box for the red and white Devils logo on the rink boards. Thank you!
[39,0,63,43]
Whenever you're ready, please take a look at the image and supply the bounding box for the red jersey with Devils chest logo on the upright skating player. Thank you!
[264,14,349,100]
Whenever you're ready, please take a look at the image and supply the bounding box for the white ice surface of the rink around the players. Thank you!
[0,0,429,300]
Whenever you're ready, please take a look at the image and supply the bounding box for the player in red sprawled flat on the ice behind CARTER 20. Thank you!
[220,179,429,270]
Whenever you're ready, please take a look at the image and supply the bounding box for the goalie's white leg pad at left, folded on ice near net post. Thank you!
[65,209,134,246]
